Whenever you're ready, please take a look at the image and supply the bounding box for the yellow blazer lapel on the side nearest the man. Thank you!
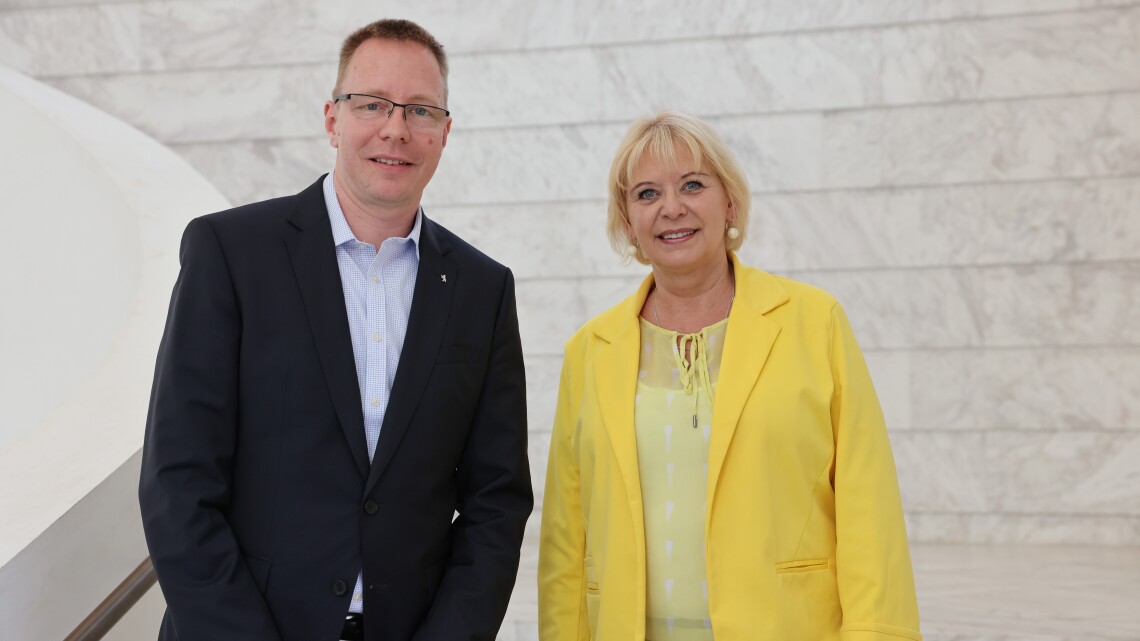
[594,275,653,528]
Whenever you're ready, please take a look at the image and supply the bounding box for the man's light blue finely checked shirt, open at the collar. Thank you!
[324,172,423,612]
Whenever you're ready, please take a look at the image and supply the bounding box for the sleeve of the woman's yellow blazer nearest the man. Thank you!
[538,343,589,641]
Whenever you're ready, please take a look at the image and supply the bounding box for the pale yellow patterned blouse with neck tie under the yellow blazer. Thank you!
[634,318,728,641]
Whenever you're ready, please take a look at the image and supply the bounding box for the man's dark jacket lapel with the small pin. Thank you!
[365,216,458,493]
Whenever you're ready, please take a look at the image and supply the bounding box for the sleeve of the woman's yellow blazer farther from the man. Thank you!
[830,303,922,641]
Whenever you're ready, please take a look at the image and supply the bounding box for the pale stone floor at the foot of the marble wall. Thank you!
[498,518,1140,641]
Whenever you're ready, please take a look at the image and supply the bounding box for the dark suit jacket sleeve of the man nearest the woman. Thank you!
[414,266,534,641]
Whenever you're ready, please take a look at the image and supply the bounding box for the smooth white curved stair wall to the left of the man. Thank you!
[0,67,228,639]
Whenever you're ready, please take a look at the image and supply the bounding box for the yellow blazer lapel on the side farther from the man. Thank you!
[706,254,788,508]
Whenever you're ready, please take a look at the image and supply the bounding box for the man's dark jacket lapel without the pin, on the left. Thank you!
[285,178,368,477]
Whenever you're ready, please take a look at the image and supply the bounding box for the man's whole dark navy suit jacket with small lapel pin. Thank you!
[139,175,534,641]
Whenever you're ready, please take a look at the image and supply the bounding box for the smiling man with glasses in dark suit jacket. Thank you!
[139,21,532,641]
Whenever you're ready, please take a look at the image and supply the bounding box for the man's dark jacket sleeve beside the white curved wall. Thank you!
[139,219,278,641]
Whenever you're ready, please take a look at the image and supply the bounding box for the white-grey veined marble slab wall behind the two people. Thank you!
[0,0,1140,545]
